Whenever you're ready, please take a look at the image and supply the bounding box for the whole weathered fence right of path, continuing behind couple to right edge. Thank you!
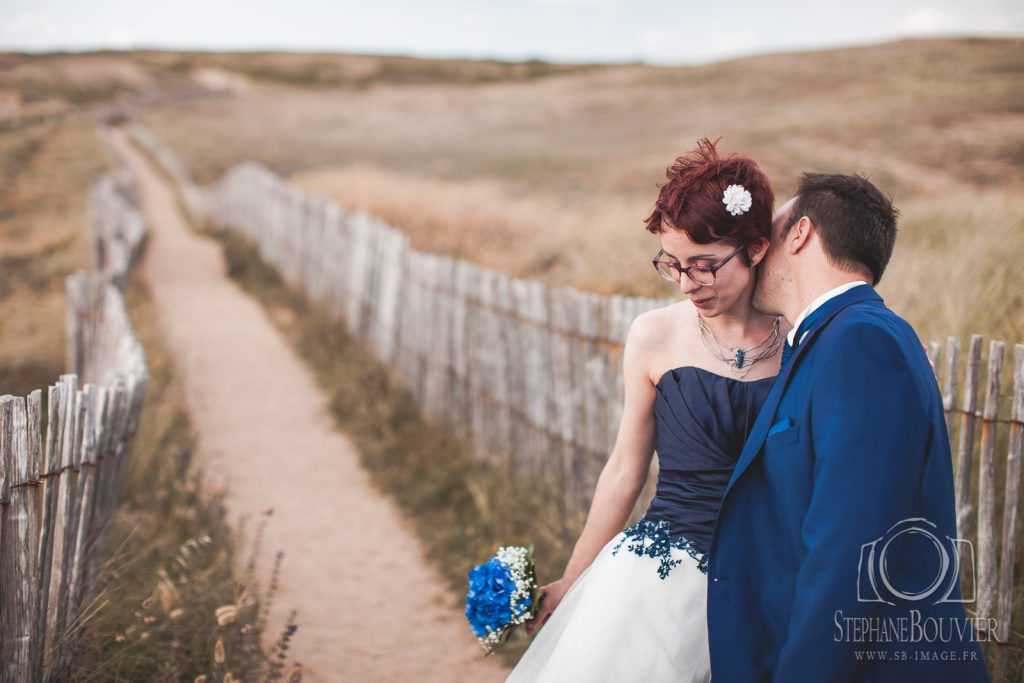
[129,125,1024,679]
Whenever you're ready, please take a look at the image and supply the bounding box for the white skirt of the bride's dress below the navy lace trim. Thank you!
[506,529,711,683]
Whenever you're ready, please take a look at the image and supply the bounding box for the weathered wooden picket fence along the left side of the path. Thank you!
[0,158,148,683]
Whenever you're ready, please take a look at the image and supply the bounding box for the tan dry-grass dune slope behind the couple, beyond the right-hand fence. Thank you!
[138,39,1024,339]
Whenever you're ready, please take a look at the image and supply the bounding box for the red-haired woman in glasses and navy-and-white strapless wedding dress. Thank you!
[506,138,790,683]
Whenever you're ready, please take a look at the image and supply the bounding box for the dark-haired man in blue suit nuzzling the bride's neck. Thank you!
[708,174,988,683]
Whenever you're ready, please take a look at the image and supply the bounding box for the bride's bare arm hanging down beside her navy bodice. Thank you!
[562,314,657,585]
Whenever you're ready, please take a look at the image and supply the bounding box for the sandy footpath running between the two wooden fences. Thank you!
[114,131,507,683]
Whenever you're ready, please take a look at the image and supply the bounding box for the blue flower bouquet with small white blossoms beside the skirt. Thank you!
[466,546,538,654]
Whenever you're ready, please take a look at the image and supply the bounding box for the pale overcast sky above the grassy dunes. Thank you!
[0,0,1024,63]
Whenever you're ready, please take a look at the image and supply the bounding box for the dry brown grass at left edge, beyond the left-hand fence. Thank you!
[0,112,113,395]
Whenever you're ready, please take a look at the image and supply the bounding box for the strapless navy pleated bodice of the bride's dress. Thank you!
[643,366,775,553]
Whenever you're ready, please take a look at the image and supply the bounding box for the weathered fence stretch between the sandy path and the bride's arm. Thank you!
[121,125,671,518]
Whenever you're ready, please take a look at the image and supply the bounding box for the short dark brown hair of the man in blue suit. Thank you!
[782,173,899,285]
